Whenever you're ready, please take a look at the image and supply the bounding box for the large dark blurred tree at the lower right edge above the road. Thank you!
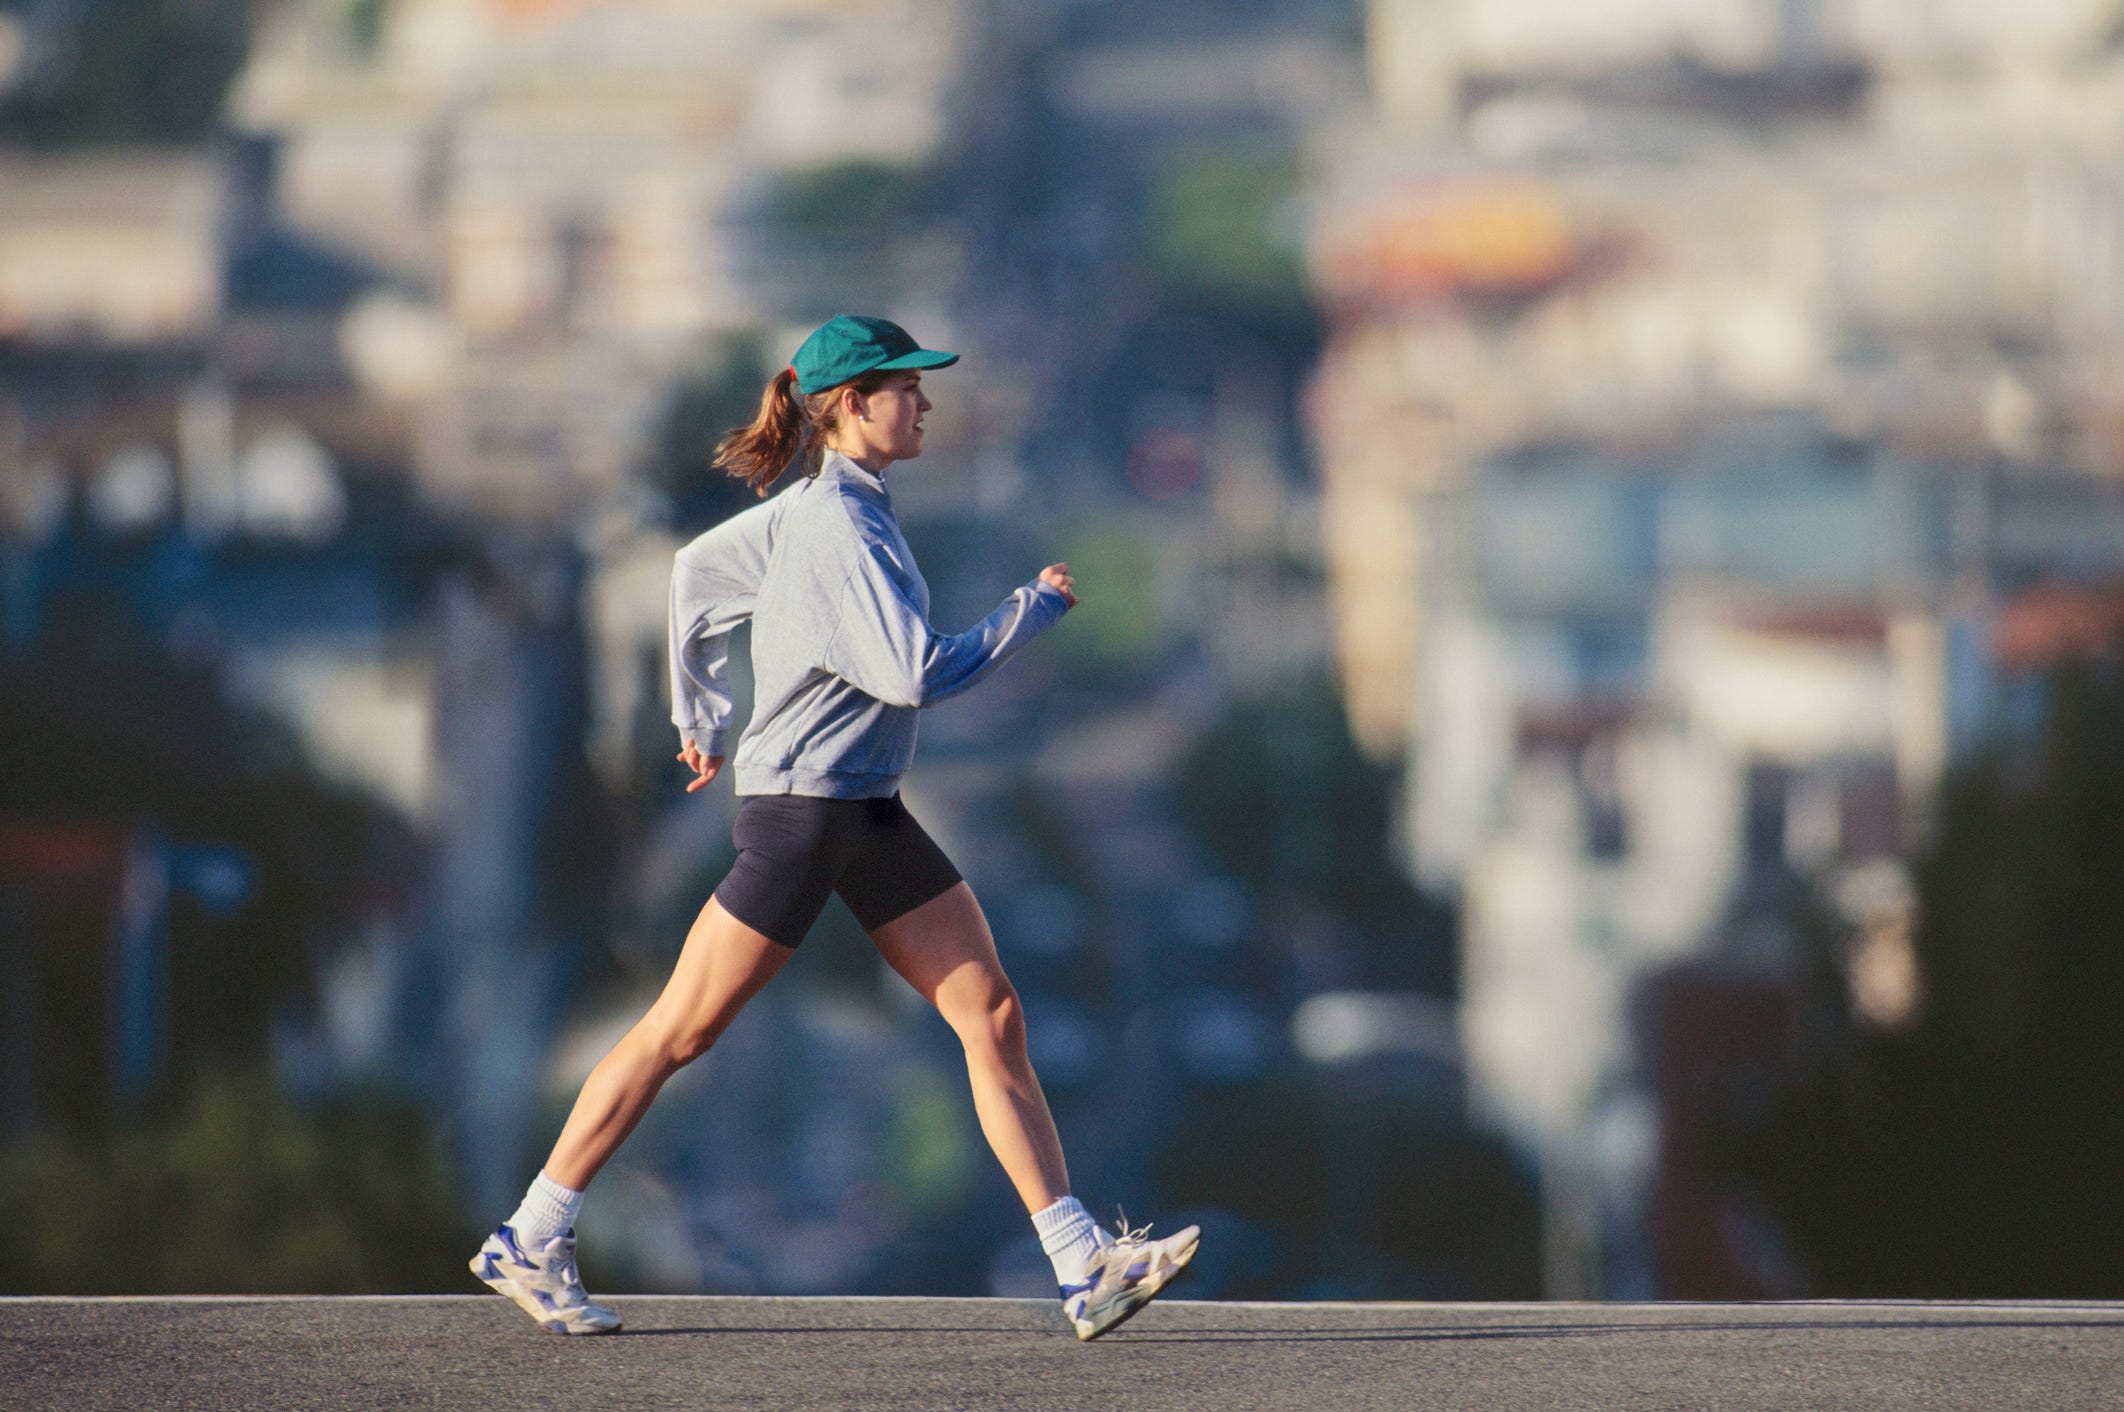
[1716,658,2124,1297]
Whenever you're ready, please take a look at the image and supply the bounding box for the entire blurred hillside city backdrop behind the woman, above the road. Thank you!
[12,0,2124,1299]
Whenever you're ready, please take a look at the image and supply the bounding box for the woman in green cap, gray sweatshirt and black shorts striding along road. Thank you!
[472,314,1200,1338]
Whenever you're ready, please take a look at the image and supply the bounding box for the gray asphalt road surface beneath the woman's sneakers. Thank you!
[0,1295,2124,1412]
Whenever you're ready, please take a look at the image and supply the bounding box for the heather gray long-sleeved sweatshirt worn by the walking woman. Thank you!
[671,450,1068,798]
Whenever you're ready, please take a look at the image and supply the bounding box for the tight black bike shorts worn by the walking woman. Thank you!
[716,794,960,947]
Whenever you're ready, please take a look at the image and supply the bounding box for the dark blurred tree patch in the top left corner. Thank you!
[0,0,251,147]
